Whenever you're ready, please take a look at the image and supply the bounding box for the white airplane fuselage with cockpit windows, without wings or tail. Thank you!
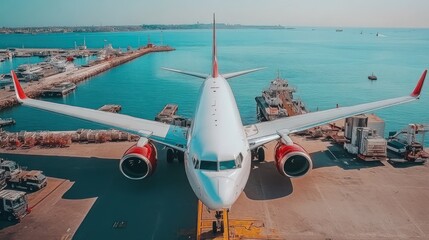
[185,76,251,210]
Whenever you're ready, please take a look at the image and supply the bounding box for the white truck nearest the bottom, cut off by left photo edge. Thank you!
[0,190,30,222]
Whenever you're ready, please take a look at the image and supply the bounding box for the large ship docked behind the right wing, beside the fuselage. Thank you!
[255,74,308,122]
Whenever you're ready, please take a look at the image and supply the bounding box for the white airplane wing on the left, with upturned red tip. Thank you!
[11,71,187,151]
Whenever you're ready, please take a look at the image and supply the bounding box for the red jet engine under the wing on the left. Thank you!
[119,142,157,180]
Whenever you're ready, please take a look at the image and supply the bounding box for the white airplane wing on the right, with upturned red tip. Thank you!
[244,70,427,149]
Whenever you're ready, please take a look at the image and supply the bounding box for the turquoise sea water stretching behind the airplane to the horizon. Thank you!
[0,28,429,145]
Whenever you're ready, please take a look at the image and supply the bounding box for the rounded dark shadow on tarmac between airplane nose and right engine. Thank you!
[244,161,293,200]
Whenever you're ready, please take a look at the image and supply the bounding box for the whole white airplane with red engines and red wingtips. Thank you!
[11,16,427,229]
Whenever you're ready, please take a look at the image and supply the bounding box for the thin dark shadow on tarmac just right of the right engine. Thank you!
[310,145,384,170]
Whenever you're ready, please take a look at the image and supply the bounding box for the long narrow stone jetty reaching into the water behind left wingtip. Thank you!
[0,45,174,111]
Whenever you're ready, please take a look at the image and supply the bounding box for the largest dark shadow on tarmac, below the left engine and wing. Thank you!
[1,154,197,239]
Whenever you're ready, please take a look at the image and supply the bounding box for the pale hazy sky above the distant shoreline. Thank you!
[0,0,429,27]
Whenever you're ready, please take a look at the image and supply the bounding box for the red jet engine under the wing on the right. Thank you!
[274,142,313,178]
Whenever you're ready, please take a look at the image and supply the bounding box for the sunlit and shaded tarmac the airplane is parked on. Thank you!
[0,137,429,239]
